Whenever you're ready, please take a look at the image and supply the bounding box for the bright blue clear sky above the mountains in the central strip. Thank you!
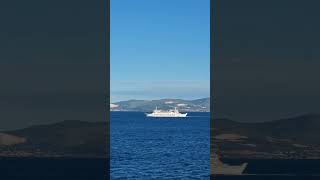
[110,0,210,102]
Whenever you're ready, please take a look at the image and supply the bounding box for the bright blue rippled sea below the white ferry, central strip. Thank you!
[110,112,210,179]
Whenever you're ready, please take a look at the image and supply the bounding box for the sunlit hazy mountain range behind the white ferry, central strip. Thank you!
[110,98,210,112]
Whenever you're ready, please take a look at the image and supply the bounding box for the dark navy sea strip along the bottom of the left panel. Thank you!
[0,157,109,180]
